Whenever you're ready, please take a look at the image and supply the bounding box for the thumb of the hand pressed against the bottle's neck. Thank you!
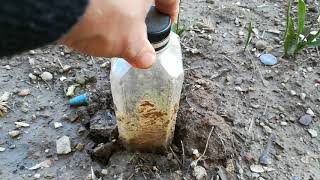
[123,23,156,69]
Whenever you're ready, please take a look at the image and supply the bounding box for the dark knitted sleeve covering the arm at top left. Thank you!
[0,0,89,57]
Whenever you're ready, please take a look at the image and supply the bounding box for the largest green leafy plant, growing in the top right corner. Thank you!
[284,0,320,57]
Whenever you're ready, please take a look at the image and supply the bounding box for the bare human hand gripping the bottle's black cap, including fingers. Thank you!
[60,0,178,68]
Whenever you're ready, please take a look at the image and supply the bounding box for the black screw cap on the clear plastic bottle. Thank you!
[146,6,171,43]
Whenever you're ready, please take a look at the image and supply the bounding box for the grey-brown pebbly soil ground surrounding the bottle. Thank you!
[0,0,320,180]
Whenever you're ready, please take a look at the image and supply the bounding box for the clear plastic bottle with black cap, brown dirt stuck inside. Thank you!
[110,7,184,152]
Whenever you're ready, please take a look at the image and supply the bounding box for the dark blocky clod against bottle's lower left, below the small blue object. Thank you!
[89,111,117,141]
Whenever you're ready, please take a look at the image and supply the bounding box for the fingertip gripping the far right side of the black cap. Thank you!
[155,0,180,22]
